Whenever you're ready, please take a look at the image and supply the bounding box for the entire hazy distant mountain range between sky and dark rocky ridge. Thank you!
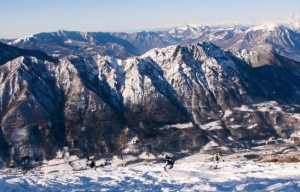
[1,19,300,66]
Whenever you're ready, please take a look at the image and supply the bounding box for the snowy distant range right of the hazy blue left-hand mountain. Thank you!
[114,22,300,66]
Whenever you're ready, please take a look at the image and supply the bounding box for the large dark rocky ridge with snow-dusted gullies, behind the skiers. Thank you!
[0,42,300,165]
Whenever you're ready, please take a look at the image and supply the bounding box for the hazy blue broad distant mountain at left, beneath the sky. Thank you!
[8,30,140,58]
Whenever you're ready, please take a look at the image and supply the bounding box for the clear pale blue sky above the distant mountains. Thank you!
[0,0,300,38]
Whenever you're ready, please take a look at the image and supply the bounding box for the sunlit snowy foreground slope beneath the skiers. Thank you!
[0,160,300,192]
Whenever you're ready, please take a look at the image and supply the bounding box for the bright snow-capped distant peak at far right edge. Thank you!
[226,23,300,66]
